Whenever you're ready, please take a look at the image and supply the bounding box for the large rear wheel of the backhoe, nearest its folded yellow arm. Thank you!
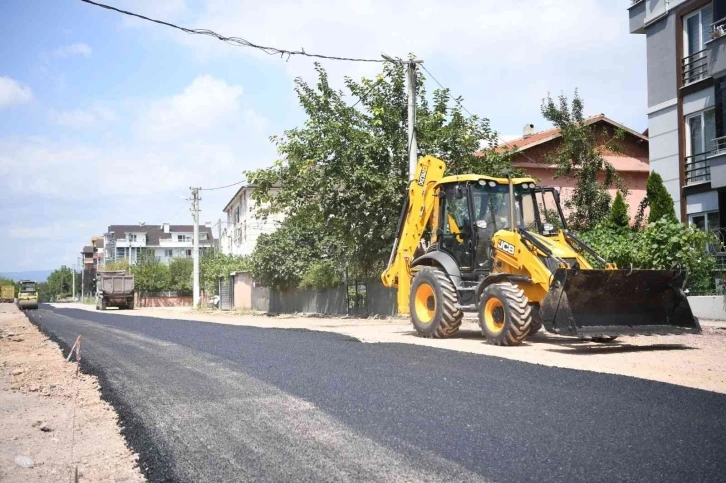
[409,267,464,339]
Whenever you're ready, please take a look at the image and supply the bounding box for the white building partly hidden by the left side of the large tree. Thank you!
[220,186,285,256]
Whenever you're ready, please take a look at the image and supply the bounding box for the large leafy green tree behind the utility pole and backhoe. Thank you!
[246,59,511,285]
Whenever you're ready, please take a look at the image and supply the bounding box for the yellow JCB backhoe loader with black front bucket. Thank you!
[381,156,701,345]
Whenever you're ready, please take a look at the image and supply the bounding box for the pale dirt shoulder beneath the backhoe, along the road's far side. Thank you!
[58,304,726,394]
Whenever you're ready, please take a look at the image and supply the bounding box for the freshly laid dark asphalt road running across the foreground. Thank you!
[22,306,726,482]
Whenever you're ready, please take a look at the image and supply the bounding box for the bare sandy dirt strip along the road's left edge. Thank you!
[0,304,145,482]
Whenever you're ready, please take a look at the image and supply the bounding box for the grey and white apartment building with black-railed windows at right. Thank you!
[628,0,726,231]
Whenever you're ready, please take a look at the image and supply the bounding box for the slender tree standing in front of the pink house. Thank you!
[542,91,627,230]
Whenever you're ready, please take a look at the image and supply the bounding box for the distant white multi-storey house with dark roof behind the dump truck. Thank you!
[104,223,214,264]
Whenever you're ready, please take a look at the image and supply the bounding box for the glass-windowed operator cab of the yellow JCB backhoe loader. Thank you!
[436,178,566,277]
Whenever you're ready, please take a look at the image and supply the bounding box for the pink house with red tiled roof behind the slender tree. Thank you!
[504,114,650,219]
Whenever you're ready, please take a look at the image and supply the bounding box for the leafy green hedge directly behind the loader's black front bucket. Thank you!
[581,217,718,291]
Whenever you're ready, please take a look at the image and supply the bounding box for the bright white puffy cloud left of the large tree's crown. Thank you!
[136,75,262,140]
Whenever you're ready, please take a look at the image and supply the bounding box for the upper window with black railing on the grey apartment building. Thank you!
[683,5,713,84]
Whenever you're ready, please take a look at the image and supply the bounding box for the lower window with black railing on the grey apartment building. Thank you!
[686,109,716,183]
